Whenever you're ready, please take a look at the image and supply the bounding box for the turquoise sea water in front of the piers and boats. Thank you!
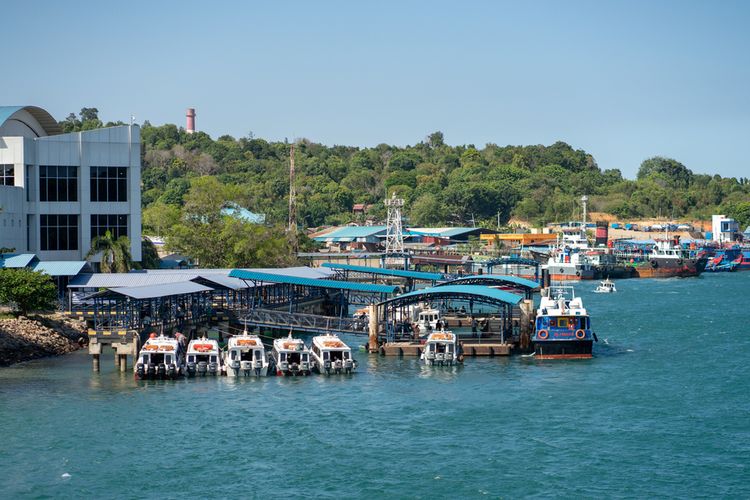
[0,273,750,498]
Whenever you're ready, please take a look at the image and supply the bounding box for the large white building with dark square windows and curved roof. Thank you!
[0,106,141,261]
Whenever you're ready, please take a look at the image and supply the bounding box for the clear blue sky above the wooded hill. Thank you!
[5,0,750,177]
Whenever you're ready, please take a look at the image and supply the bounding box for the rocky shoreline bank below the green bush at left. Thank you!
[0,314,88,366]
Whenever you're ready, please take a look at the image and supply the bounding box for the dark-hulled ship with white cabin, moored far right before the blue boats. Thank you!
[635,236,707,278]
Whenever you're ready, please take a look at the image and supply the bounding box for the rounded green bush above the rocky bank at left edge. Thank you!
[0,267,57,314]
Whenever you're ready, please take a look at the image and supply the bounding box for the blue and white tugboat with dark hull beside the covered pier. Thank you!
[531,287,596,359]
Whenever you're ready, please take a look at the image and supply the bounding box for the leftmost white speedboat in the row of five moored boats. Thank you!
[133,333,185,380]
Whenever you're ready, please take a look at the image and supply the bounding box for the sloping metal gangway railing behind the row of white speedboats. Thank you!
[240,309,368,335]
